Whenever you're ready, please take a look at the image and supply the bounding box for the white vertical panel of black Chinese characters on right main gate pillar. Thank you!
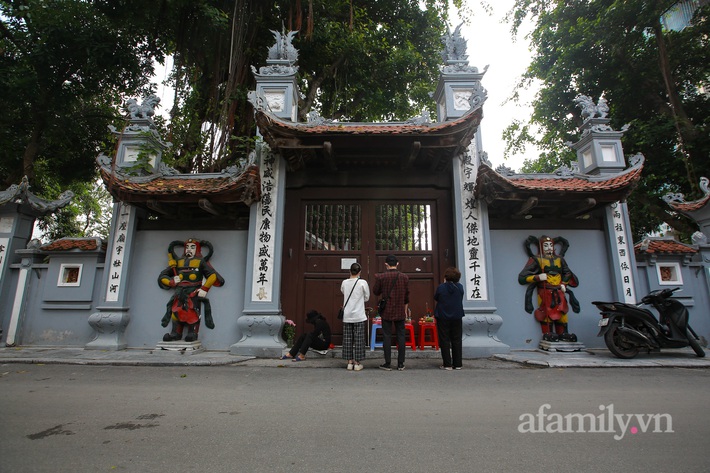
[461,153,488,300]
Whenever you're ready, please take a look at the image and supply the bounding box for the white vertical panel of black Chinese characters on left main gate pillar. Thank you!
[251,152,279,302]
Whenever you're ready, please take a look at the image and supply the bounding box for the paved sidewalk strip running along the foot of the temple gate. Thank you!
[0,347,710,369]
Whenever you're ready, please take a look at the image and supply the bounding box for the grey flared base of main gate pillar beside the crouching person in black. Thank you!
[229,315,286,358]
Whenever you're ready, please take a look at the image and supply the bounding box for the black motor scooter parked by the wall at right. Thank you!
[592,287,705,358]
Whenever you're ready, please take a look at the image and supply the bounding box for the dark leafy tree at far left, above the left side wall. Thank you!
[0,0,159,189]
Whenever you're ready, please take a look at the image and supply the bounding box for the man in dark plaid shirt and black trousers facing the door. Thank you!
[372,255,409,371]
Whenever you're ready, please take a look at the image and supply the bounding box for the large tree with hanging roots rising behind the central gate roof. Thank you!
[147,0,461,172]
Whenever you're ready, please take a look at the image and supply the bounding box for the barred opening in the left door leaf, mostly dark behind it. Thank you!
[305,204,362,251]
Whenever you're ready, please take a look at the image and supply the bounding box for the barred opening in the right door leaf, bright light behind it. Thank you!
[375,204,432,251]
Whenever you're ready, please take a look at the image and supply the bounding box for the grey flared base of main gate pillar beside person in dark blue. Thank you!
[462,309,510,358]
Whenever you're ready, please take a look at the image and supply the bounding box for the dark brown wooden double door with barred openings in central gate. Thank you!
[281,189,456,345]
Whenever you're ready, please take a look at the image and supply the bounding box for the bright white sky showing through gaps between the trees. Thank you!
[156,0,539,171]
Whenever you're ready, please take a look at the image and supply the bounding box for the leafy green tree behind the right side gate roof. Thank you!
[505,0,710,238]
